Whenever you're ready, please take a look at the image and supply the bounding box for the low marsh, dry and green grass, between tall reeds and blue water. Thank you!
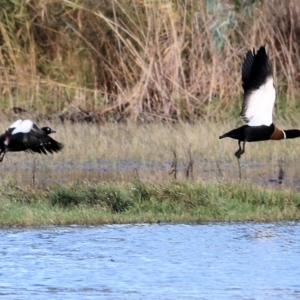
[0,123,300,225]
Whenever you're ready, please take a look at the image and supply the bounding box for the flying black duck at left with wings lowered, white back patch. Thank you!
[0,119,63,162]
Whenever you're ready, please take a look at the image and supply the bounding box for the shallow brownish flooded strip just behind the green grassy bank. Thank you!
[0,159,300,190]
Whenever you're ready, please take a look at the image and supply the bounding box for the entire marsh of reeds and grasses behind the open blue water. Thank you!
[0,0,300,225]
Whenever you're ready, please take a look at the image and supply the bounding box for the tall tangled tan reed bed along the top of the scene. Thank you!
[0,0,300,121]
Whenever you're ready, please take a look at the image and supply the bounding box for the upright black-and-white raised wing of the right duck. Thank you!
[240,46,276,126]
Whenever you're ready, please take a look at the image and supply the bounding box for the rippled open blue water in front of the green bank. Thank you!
[0,222,300,300]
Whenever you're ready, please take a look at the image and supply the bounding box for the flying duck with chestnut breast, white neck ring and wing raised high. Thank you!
[219,46,300,159]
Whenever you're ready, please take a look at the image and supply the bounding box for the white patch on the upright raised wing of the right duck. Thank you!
[240,77,276,126]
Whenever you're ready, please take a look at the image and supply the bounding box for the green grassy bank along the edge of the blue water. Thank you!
[0,181,300,226]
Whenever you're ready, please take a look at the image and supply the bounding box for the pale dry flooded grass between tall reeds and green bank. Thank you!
[0,121,300,186]
